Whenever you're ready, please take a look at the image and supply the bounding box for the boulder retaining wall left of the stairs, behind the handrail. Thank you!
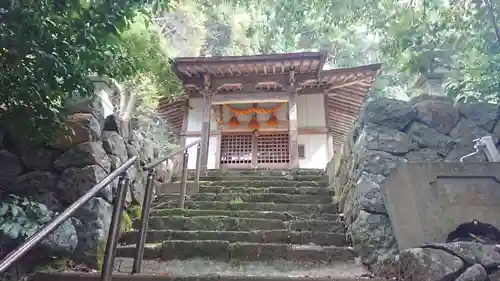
[0,84,172,267]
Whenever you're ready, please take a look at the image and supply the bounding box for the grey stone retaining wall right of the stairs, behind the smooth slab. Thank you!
[327,96,500,265]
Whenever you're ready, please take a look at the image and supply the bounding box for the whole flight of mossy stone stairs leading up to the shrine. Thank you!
[34,170,386,281]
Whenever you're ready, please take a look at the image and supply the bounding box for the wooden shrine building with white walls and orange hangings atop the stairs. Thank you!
[158,52,380,169]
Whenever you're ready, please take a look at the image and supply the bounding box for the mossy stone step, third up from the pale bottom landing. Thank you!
[139,216,345,233]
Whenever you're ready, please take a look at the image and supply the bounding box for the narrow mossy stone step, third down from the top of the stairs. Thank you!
[200,186,334,196]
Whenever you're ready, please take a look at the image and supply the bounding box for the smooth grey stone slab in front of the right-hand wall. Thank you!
[381,163,500,250]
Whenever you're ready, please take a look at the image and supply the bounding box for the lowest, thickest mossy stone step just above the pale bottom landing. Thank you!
[117,240,356,263]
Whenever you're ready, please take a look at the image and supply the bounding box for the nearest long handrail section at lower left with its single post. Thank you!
[0,156,137,281]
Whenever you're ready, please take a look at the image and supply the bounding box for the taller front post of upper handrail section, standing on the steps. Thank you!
[132,168,156,274]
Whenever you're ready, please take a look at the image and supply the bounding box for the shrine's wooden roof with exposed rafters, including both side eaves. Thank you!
[159,52,381,147]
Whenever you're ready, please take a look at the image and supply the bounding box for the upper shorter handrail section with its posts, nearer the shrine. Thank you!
[132,140,201,274]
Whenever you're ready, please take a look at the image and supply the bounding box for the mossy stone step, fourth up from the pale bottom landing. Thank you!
[150,201,338,215]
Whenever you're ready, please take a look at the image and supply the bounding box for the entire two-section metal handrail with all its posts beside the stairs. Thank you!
[0,140,201,281]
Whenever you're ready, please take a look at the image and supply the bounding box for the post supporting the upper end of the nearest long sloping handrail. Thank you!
[101,173,129,281]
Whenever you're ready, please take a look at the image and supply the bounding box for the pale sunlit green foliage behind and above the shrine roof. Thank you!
[157,0,500,102]
